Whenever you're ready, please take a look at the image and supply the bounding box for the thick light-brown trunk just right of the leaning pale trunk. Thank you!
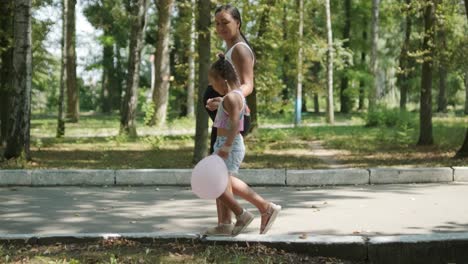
[150,0,174,126]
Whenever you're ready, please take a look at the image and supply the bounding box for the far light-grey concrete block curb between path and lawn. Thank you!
[0,167,468,186]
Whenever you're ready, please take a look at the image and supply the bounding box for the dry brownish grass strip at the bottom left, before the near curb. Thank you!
[0,239,358,264]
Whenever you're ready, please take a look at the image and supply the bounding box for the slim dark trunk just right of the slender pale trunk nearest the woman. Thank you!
[340,0,352,113]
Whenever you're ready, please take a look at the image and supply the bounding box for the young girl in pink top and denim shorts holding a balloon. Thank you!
[205,54,281,236]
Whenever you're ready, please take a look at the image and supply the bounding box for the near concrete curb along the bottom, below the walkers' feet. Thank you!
[0,232,468,263]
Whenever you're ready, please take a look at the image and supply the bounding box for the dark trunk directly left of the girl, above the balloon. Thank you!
[193,0,211,163]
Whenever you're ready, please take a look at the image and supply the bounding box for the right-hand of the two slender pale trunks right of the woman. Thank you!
[369,0,380,112]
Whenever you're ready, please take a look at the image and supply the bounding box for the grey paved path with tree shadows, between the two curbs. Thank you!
[0,183,468,236]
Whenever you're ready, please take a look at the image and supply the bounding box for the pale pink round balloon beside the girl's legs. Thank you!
[191,154,229,199]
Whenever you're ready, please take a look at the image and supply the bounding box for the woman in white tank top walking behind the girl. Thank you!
[204,5,277,235]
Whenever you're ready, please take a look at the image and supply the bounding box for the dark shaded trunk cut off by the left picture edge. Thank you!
[0,0,13,147]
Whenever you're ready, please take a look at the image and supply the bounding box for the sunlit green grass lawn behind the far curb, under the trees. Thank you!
[0,113,468,169]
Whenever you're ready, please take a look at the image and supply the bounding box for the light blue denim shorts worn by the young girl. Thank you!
[214,134,245,176]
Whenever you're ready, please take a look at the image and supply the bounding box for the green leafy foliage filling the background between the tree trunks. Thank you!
[21,0,468,128]
